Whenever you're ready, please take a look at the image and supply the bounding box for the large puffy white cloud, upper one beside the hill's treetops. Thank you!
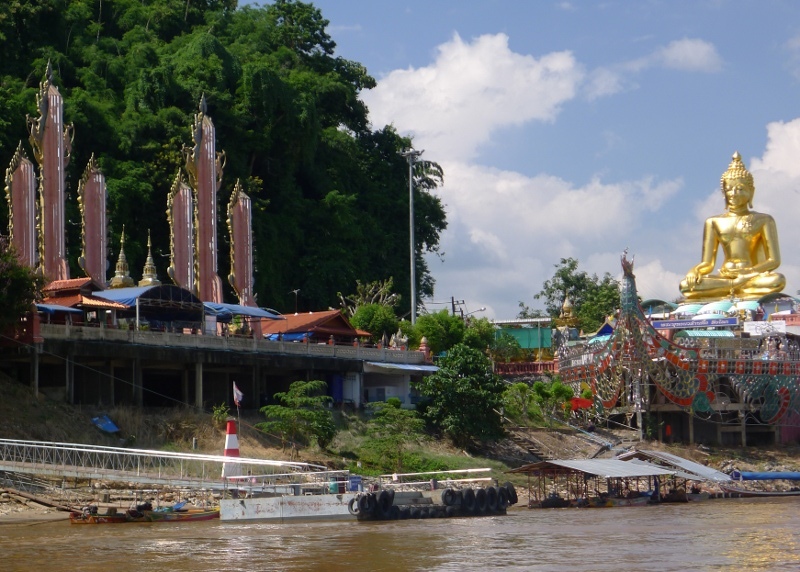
[363,34,583,159]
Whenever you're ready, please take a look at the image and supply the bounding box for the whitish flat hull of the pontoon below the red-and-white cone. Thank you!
[219,493,356,522]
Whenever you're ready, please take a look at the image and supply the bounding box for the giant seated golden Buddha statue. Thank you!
[680,152,786,301]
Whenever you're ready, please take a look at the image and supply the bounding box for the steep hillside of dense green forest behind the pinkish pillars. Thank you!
[0,0,447,314]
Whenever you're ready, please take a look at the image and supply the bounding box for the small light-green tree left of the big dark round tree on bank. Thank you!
[367,397,425,473]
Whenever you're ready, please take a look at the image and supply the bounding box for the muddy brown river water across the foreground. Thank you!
[0,498,800,572]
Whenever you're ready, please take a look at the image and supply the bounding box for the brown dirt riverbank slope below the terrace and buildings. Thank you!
[0,376,800,522]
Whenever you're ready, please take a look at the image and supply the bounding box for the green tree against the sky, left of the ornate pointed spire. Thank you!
[532,258,620,332]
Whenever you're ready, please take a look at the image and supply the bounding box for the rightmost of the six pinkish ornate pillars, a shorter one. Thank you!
[228,180,257,306]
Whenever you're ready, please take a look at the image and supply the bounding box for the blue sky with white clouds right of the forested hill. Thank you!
[248,0,800,320]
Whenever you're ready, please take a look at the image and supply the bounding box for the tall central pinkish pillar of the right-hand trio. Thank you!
[184,94,225,303]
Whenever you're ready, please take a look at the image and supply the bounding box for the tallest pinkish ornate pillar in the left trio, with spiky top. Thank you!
[28,62,73,280]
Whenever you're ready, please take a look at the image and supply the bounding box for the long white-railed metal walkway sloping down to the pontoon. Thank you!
[0,439,331,489]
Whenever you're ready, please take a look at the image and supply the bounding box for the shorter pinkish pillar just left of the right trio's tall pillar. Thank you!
[167,170,195,292]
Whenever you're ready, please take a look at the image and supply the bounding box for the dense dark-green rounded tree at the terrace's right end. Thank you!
[417,344,504,446]
